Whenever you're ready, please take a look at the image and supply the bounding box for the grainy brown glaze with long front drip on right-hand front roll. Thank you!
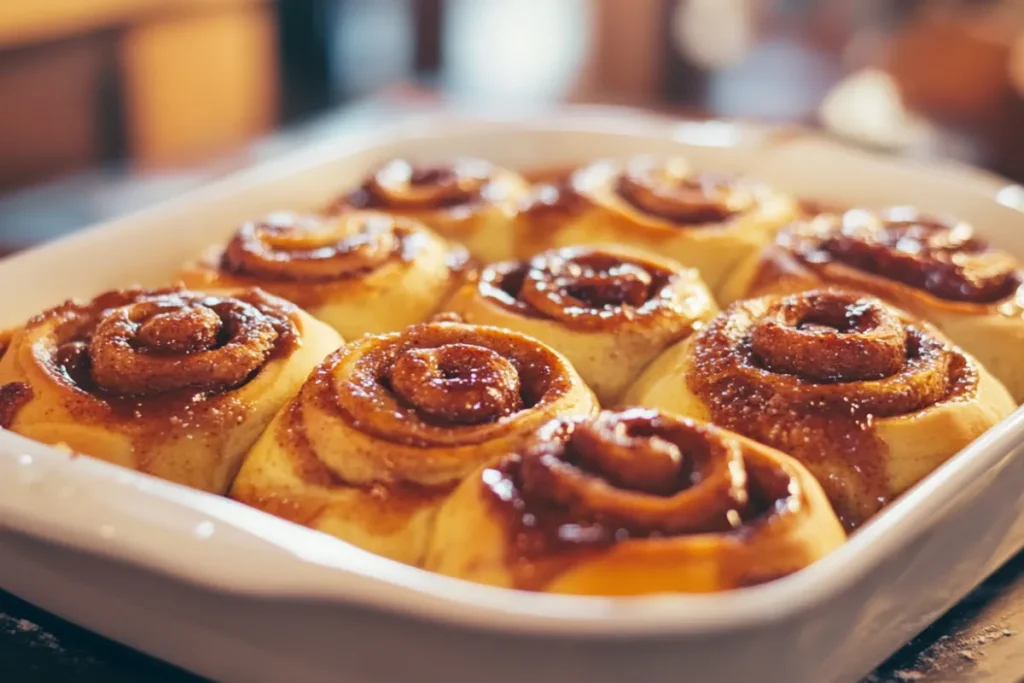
[685,291,978,528]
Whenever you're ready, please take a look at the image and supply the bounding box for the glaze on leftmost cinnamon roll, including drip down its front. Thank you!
[27,288,301,428]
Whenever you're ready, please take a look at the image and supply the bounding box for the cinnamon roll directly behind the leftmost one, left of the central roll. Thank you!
[180,211,468,339]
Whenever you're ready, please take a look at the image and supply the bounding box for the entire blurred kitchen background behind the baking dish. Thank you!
[0,0,1024,251]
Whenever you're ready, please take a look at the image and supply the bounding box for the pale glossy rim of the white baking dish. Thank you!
[0,108,1024,638]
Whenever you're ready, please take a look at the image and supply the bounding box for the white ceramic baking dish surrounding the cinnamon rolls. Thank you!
[0,112,1024,683]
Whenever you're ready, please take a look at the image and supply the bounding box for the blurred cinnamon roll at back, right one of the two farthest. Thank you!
[517,157,799,292]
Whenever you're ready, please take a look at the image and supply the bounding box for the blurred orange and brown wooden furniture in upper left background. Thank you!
[0,0,278,190]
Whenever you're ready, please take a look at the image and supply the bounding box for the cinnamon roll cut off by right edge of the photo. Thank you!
[723,207,1024,403]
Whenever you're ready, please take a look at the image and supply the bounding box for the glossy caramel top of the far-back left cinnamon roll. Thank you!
[347,159,495,211]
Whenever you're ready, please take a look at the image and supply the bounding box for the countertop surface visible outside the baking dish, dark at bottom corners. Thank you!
[0,100,1024,683]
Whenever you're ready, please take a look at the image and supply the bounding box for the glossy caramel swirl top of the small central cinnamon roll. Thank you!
[478,247,687,330]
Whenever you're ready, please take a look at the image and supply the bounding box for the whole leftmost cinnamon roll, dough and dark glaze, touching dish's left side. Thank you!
[0,289,341,494]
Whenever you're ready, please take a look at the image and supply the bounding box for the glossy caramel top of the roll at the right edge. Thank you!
[778,207,1022,303]
